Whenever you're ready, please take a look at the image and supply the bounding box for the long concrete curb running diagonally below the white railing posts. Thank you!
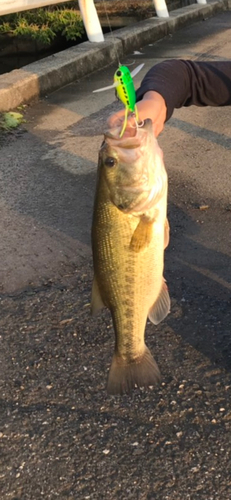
[0,0,231,112]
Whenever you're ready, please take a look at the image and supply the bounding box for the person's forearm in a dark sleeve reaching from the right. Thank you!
[137,59,231,121]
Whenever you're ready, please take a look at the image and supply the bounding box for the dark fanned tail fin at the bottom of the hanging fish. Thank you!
[107,347,160,395]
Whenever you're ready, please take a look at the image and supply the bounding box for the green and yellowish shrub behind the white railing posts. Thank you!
[0,7,85,45]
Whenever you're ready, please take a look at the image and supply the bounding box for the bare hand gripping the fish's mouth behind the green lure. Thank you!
[107,91,167,137]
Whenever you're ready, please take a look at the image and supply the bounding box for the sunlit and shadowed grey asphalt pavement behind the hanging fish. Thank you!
[0,7,231,500]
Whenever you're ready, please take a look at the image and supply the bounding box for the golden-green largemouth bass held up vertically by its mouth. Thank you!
[91,119,170,394]
